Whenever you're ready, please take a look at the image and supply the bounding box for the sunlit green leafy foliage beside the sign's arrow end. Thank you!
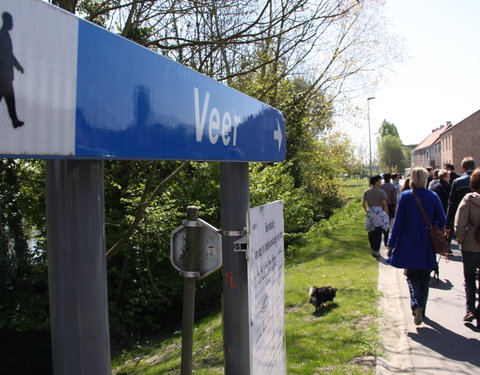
[231,45,351,256]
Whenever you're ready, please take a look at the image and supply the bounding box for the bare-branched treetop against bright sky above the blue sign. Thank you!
[72,0,400,105]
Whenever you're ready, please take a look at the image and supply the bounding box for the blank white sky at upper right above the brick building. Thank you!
[346,0,480,150]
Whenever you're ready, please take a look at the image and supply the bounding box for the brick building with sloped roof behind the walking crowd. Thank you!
[411,111,480,173]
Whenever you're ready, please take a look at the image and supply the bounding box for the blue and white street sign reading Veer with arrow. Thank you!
[0,0,285,162]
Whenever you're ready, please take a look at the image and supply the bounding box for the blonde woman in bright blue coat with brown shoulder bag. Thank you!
[387,167,445,325]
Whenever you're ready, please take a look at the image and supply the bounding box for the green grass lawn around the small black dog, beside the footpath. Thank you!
[113,180,381,375]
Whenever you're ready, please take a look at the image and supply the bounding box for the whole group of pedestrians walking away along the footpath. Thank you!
[363,157,480,326]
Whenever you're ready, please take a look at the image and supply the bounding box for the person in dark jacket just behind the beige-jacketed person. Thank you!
[445,156,475,239]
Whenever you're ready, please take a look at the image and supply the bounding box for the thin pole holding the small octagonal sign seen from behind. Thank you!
[181,206,198,375]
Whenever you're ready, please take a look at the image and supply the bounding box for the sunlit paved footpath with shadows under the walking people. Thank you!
[376,243,480,375]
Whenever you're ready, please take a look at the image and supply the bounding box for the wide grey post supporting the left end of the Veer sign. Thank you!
[46,160,110,375]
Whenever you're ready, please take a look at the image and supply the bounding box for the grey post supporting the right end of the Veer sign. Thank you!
[220,162,250,375]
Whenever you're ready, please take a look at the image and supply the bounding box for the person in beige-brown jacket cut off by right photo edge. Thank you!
[454,168,480,327]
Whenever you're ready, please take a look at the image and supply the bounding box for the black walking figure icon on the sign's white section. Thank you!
[0,12,24,128]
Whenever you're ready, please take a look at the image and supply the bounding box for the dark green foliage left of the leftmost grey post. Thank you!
[0,159,49,331]
